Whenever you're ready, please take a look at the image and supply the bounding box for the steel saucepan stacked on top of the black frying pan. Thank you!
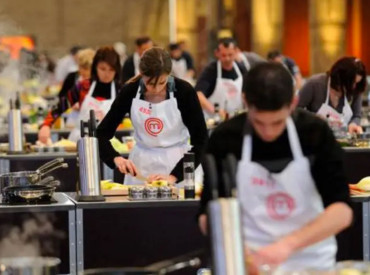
[0,158,68,190]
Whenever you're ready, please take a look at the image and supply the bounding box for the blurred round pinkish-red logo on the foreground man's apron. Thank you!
[266,193,296,221]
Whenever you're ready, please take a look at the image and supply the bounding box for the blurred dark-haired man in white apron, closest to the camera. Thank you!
[199,63,352,274]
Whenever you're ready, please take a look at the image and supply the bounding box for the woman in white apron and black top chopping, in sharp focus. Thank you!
[97,48,207,184]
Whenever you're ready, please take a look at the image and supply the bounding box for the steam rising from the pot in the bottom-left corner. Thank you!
[0,213,66,258]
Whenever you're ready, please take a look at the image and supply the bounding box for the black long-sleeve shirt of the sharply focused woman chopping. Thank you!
[97,78,208,181]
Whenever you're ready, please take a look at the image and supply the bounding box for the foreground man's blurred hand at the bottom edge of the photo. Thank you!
[252,240,294,266]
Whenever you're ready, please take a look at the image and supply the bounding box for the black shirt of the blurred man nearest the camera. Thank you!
[200,110,349,216]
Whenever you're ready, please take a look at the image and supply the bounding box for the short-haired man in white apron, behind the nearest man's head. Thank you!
[195,38,246,118]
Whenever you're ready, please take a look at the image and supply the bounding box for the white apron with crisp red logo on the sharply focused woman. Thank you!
[124,77,197,184]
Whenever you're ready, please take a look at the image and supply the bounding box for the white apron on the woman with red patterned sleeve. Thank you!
[68,81,116,142]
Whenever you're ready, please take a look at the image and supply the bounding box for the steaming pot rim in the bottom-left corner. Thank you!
[0,257,60,275]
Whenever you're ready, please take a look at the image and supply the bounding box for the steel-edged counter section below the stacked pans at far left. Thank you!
[0,193,77,274]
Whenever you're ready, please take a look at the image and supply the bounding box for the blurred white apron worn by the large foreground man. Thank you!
[237,117,337,270]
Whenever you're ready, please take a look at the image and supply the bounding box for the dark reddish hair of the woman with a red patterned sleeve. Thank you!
[91,46,121,84]
